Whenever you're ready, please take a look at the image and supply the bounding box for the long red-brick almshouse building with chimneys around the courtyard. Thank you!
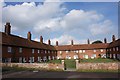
[0,22,120,63]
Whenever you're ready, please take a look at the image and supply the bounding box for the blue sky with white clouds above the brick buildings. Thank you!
[0,0,118,45]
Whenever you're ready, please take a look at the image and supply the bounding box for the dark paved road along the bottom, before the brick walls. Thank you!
[3,71,118,78]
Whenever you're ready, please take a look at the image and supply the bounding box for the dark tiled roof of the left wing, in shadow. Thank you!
[0,32,55,50]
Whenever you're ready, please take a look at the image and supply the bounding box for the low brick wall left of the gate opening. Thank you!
[2,63,64,70]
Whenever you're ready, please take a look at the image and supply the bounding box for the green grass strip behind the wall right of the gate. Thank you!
[80,58,119,63]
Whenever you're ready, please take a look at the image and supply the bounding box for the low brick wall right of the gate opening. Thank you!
[76,63,120,70]
